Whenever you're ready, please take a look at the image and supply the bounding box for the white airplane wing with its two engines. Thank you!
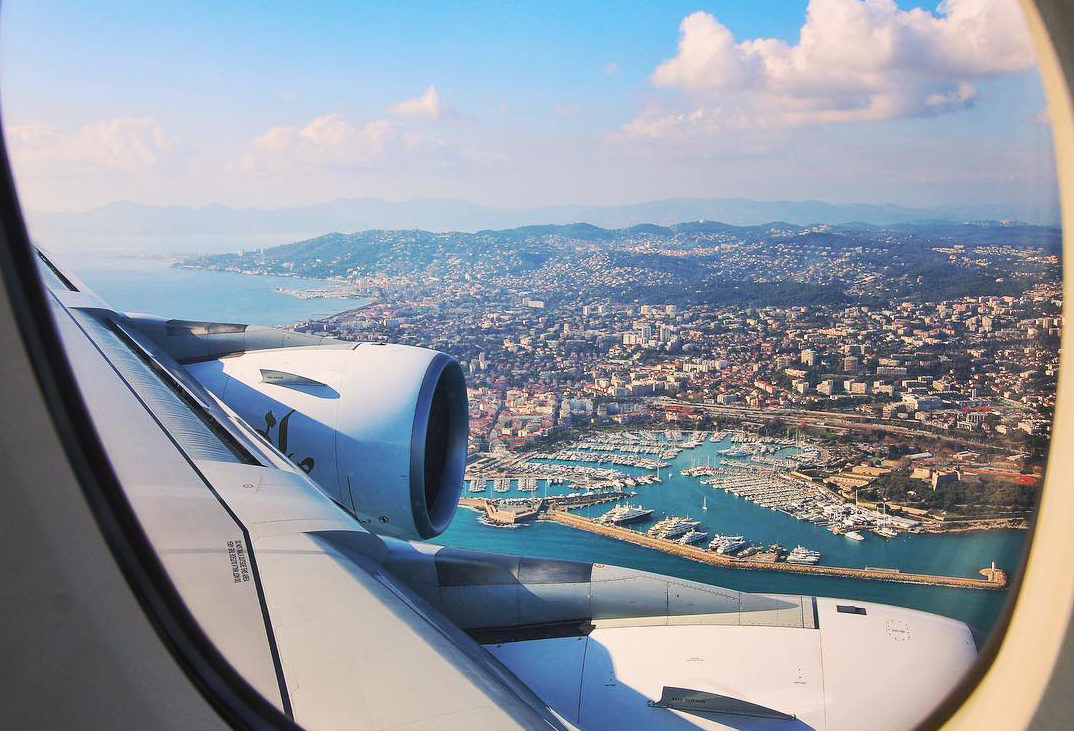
[41,247,975,730]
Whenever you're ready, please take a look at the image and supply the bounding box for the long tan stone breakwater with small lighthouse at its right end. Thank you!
[538,508,1007,591]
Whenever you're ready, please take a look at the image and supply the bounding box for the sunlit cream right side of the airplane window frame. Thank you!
[923,0,1074,729]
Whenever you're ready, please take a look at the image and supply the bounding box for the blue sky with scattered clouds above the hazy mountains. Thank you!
[0,0,1056,216]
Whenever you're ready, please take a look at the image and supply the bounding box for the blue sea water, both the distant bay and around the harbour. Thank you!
[61,254,1028,633]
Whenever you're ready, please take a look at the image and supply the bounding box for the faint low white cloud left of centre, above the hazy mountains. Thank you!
[235,114,500,172]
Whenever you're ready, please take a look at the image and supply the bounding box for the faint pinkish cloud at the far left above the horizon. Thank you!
[6,117,182,172]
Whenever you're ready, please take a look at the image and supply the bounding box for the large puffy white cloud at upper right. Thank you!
[624,0,1035,137]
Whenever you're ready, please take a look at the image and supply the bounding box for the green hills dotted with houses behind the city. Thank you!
[182,221,1060,306]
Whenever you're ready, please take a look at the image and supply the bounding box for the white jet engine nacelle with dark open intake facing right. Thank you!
[187,342,468,539]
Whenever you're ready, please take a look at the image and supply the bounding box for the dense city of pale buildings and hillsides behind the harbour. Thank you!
[182,216,1061,529]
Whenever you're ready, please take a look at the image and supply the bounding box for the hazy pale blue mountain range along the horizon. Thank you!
[28,198,1059,252]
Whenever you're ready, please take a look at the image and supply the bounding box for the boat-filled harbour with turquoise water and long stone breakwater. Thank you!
[451,430,1024,613]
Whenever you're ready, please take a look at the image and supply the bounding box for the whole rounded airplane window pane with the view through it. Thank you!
[0,0,1063,729]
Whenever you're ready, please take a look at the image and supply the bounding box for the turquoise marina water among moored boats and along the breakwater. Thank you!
[445,430,1025,627]
